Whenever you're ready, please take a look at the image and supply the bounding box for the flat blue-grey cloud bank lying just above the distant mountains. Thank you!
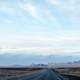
[0,54,80,66]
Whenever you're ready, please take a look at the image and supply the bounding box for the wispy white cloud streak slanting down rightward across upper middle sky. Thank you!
[19,2,63,33]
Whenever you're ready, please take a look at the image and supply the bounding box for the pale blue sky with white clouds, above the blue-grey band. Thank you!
[0,0,80,55]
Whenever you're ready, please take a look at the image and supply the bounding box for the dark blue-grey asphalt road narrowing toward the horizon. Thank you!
[8,69,69,80]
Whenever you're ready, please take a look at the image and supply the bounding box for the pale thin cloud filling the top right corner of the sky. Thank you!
[47,0,80,20]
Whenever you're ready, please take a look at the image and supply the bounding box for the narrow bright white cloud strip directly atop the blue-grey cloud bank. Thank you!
[0,47,80,55]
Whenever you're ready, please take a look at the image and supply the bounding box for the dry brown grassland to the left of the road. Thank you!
[0,68,41,77]
